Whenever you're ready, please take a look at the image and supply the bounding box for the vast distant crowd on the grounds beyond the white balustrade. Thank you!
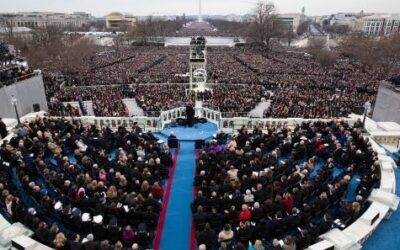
[38,46,385,118]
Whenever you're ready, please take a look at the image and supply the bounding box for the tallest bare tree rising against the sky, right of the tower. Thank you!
[247,2,280,55]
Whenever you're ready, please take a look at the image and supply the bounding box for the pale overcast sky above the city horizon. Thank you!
[0,0,400,17]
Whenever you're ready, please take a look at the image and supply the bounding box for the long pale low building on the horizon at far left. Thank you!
[0,12,95,29]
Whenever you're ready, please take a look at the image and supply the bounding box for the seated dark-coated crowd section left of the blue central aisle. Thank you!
[0,117,173,250]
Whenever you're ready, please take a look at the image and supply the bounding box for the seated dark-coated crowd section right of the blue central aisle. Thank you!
[191,120,381,250]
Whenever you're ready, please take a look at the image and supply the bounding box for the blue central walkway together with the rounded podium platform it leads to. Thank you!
[154,123,217,250]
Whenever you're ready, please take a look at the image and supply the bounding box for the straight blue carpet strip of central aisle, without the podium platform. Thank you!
[160,142,195,250]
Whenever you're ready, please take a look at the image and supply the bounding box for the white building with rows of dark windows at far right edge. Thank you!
[362,15,400,36]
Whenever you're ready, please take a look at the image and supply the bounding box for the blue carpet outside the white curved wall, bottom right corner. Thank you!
[363,165,400,250]
